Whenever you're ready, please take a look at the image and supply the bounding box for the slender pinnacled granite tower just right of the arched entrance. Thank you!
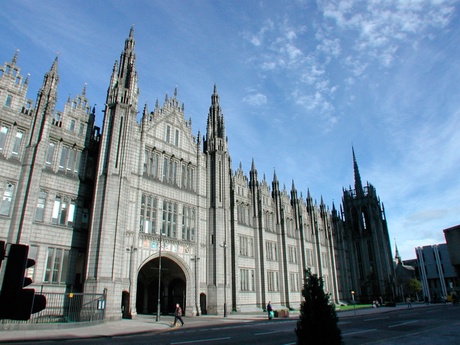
[204,86,232,315]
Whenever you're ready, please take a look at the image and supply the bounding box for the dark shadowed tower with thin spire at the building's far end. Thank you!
[342,150,395,301]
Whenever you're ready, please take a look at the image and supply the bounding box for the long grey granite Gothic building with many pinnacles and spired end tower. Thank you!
[0,29,394,319]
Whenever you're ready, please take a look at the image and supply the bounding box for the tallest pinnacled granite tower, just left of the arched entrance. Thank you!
[85,28,139,319]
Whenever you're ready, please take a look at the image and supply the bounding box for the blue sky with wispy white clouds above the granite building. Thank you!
[0,0,460,259]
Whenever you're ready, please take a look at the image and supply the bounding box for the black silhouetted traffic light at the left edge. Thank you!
[0,244,46,320]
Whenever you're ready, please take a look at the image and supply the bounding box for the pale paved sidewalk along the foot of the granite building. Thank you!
[0,303,429,343]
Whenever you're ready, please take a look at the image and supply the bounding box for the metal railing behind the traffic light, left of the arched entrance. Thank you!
[0,292,105,324]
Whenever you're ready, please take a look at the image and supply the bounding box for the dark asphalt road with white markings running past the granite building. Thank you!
[4,304,460,345]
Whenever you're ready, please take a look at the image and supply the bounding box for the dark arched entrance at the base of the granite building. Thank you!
[136,256,187,314]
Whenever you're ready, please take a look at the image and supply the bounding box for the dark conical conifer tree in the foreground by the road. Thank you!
[295,269,343,345]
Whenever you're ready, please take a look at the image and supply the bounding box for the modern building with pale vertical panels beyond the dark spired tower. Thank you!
[415,243,457,302]
